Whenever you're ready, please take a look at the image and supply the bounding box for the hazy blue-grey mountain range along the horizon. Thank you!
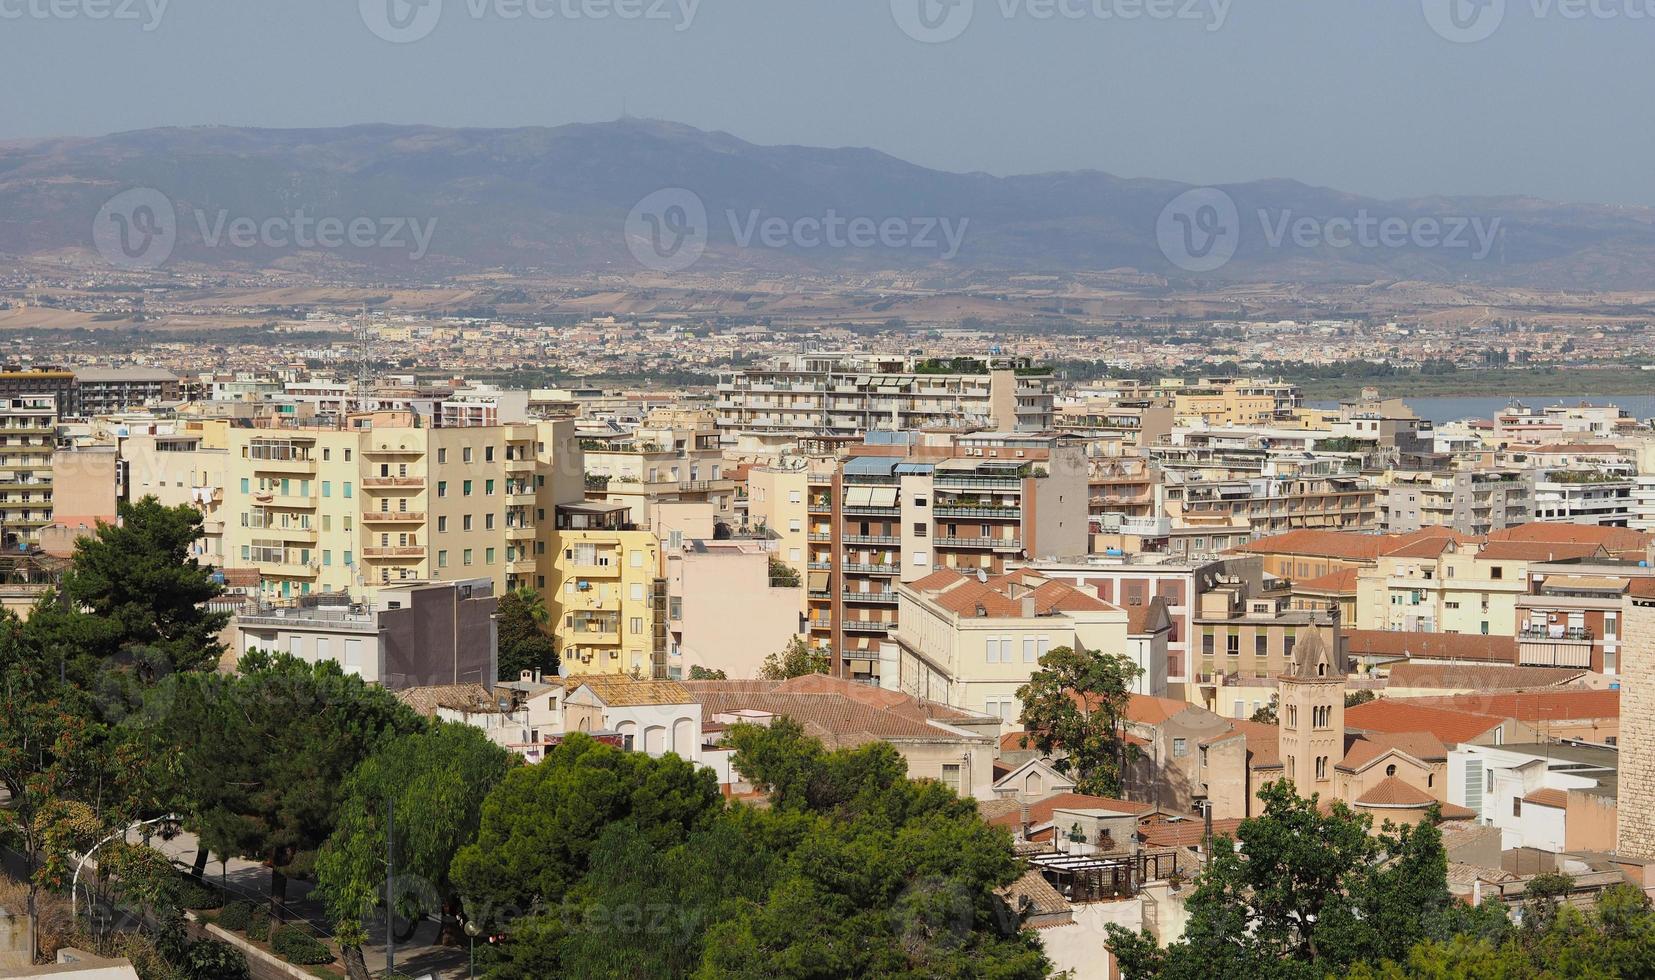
[0,119,1655,290]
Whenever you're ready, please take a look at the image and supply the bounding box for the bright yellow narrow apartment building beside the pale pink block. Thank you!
[548,502,670,679]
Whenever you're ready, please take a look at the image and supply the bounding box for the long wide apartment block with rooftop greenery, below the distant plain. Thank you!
[717,351,1056,437]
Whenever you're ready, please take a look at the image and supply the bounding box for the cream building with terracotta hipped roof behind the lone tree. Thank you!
[880,569,1145,727]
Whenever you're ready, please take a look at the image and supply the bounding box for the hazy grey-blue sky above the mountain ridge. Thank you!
[0,0,1655,205]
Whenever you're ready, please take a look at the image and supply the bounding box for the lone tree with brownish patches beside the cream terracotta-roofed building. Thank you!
[1018,647,1144,796]
